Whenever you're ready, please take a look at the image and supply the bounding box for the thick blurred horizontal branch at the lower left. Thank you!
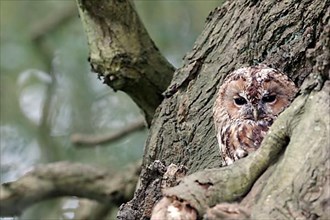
[0,162,140,216]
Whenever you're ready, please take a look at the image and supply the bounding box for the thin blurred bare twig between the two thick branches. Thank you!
[71,120,145,147]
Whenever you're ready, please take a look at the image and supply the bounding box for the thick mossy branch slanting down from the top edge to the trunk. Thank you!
[77,0,175,125]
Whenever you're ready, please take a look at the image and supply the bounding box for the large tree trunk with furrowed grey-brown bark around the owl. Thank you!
[118,0,330,219]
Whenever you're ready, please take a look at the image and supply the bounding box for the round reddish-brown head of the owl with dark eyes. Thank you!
[218,66,297,121]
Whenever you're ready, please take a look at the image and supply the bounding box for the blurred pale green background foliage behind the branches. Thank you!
[0,0,221,219]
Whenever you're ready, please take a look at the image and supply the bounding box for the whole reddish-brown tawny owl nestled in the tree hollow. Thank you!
[213,65,297,165]
